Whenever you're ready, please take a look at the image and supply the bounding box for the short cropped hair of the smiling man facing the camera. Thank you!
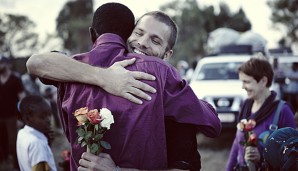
[136,11,178,50]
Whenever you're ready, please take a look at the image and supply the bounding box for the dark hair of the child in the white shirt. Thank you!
[19,95,46,120]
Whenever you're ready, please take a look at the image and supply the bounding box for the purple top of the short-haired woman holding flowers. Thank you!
[226,104,296,171]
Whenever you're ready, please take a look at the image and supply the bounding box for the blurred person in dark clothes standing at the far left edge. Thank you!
[0,56,25,169]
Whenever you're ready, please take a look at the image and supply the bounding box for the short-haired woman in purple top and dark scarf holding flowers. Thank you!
[226,57,296,171]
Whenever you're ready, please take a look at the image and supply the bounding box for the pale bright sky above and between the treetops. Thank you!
[0,0,282,48]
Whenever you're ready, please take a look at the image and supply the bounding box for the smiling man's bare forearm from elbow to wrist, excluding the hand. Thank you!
[26,52,104,85]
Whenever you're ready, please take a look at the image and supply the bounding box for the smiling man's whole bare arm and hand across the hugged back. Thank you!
[26,52,156,104]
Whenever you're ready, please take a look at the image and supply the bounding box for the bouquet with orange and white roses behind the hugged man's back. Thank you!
[73,107,114,155]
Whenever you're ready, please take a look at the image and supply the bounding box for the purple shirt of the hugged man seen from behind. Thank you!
[58,34,221,170]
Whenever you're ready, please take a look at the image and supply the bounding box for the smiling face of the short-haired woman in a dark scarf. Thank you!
[239,71,268,100]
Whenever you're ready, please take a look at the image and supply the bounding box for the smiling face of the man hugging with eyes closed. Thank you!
[127,15,172,59]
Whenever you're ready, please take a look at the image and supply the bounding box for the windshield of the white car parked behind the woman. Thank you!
[197,62,241,80]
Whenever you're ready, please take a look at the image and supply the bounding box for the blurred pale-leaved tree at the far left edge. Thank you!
[0,14,38,58]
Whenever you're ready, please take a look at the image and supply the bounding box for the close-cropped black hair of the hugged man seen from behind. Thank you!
[92,3,135,42]
